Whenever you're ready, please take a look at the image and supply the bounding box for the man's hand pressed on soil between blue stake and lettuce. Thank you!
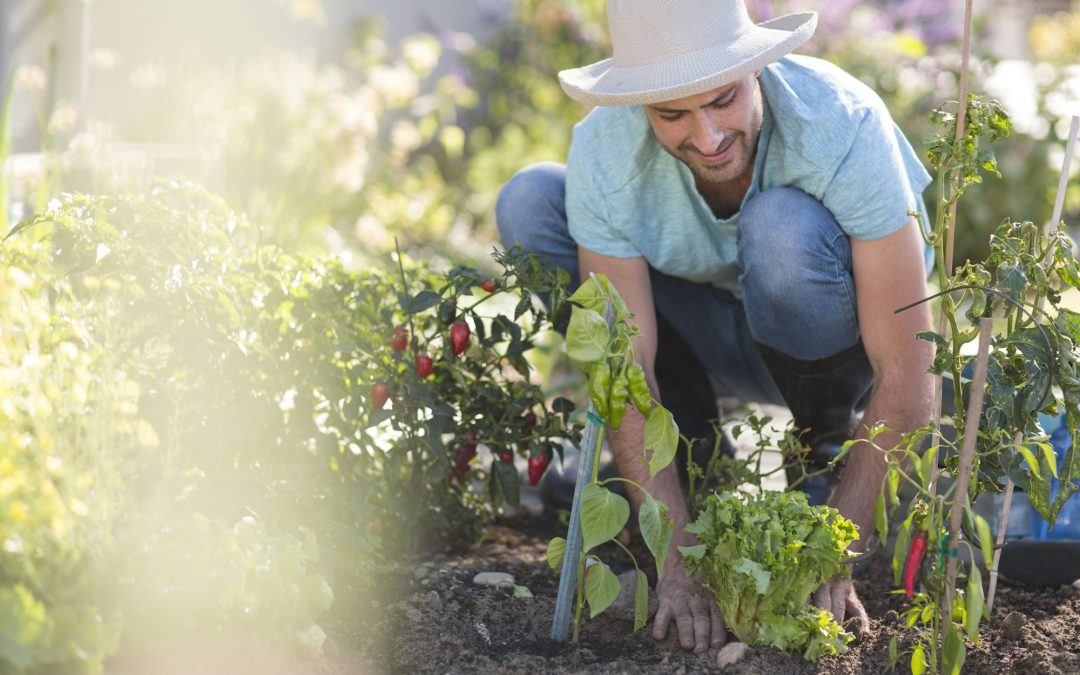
[652,553,728,653]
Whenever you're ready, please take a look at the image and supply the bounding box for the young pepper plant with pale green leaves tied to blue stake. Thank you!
[548,274,678,642]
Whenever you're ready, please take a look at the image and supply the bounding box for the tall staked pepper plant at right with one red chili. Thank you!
[877,96,1080,675]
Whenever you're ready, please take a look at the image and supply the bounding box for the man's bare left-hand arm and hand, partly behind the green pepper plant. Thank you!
[578,247,727,653]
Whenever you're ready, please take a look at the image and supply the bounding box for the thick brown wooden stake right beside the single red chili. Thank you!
[942,316,994,645]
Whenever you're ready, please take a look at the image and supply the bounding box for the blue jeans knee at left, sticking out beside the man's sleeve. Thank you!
[495,162,566,251]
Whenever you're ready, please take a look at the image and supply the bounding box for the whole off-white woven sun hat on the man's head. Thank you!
[558,0,818,106]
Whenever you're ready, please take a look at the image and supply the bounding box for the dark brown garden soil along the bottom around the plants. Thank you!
[329,515,1080,675]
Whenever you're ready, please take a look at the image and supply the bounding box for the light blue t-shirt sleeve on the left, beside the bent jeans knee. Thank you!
[566,130,642,258]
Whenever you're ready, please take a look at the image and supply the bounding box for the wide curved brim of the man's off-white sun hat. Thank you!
[558,12,818,106]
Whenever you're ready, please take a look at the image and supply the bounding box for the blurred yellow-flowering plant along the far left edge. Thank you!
[0,240,141,672]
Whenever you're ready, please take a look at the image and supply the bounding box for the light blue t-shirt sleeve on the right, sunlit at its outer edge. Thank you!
[822,107,930,240]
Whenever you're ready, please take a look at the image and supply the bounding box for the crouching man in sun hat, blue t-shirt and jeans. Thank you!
[497,0,933,652]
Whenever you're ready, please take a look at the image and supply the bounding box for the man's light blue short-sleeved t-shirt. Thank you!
[566,56,930,293]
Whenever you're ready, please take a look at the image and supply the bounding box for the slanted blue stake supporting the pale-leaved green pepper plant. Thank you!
[551,300,615,643]
